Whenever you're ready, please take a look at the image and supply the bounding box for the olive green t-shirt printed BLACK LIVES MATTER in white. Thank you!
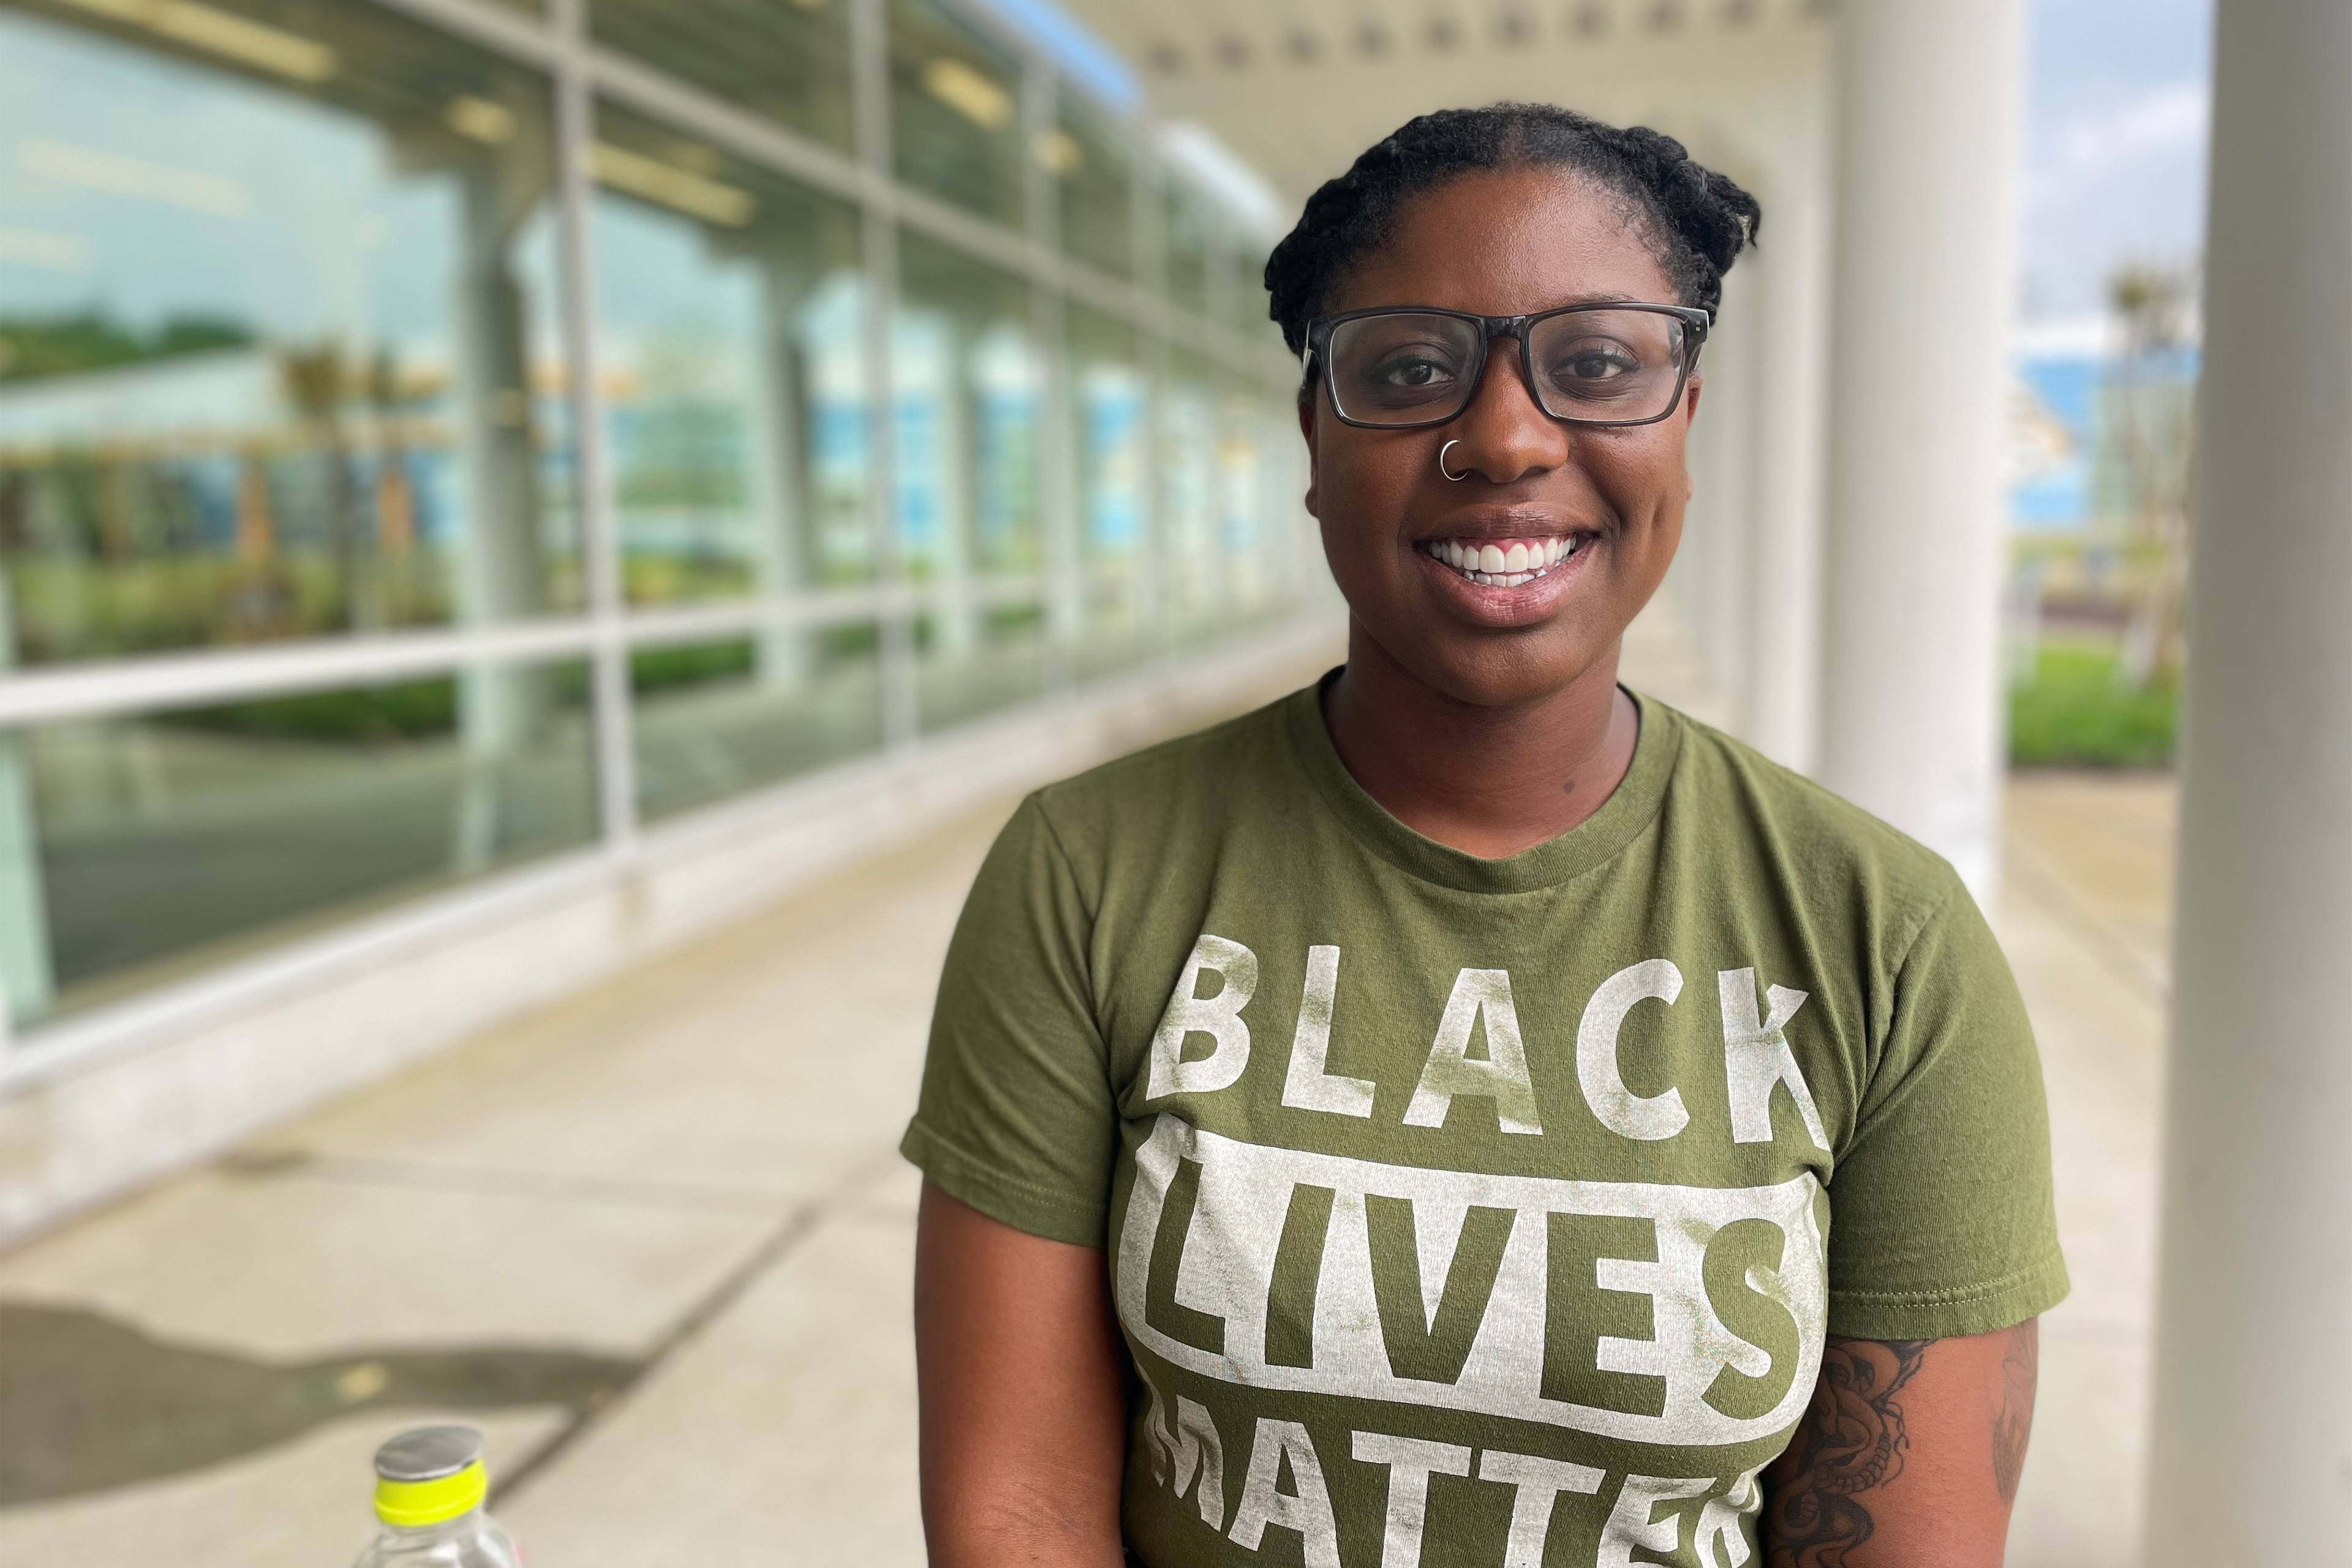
[903,689,2065,1568]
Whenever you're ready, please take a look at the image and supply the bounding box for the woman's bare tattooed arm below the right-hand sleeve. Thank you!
[1762,1319,2037,1568]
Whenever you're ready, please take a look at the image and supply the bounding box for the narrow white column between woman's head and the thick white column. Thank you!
[1741,94,1832,774]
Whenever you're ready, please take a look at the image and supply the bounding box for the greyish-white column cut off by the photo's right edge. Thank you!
[2147,0,2352,1568]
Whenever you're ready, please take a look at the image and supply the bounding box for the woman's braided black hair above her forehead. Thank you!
[1265,104,1764,353]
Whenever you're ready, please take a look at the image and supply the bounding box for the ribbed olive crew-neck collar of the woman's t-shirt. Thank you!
[1286,670,1682,893]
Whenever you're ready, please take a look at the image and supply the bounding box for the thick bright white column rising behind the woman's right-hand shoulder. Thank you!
[1820,0,2022,898]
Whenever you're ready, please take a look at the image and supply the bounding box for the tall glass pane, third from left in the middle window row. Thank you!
[891,235,1044,582]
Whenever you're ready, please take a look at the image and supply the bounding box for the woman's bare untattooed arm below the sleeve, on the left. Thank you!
[915,1183,1126,1568]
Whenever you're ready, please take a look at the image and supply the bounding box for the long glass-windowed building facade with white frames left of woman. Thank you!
[0,0,1322,1072]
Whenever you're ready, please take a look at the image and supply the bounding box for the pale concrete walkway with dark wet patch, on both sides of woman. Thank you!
[0,668,2171,1568]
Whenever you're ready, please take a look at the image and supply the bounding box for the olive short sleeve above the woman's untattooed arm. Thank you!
[899,797,1117,1246]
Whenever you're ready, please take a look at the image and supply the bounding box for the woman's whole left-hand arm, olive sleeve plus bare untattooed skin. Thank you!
[901,797,1126,1568]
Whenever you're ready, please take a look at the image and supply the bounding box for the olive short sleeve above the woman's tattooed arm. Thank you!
[1830,881,2067,1340]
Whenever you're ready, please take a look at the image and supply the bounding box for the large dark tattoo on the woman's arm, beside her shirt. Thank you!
[1766,1338,1933,1568]
